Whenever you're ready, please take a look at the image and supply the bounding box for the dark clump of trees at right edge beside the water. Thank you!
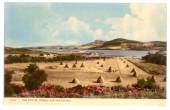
[142,52,166,65]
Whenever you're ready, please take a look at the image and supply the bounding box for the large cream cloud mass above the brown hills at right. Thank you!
[100,3,166,41]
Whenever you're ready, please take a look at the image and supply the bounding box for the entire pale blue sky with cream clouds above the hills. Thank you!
[4,3,166,47]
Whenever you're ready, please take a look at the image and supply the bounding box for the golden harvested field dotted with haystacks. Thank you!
[5,57,166,88]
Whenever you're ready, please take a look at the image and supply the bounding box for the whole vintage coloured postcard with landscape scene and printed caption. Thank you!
[4,2,167,106]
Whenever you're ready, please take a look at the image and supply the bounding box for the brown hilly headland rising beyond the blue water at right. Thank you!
[81,38,166,50]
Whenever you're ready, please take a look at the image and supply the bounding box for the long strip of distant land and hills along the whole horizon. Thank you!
[5,38,167,53]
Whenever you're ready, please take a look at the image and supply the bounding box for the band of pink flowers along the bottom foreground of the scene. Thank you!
[13,85,142,98]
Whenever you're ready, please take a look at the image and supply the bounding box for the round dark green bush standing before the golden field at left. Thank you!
[22,64,47,90]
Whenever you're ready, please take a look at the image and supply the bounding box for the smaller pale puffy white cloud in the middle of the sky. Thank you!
[41,16,95,45]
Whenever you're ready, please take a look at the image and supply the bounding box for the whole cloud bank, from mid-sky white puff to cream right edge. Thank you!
[38,4,166,44]
